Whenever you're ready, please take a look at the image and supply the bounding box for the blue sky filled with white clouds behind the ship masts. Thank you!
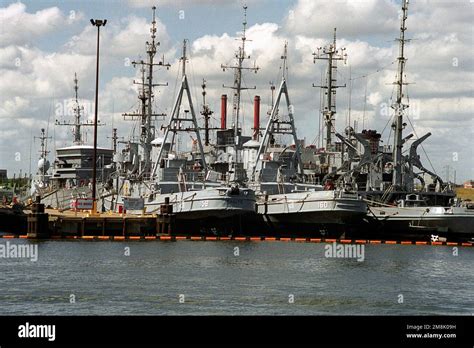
[0,0,474,183]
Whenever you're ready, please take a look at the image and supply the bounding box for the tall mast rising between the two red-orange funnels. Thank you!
[221,6,259,158]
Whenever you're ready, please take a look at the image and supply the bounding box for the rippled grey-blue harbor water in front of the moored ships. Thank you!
[0,239,474,315]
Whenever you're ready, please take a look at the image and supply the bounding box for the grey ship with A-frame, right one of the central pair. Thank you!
[244,43,367,238]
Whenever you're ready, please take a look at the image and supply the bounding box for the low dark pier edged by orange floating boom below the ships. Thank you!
[11,199,474,247]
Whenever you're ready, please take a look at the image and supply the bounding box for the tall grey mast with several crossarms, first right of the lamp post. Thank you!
[123,6,170,177]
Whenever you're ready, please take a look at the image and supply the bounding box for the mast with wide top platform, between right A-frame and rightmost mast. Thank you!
[313,28,347,151]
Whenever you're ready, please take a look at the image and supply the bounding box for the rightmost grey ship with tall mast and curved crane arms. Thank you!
[360,0,474,240]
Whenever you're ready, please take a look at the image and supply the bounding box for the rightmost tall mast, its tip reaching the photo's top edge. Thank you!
[392,0,408,189]
